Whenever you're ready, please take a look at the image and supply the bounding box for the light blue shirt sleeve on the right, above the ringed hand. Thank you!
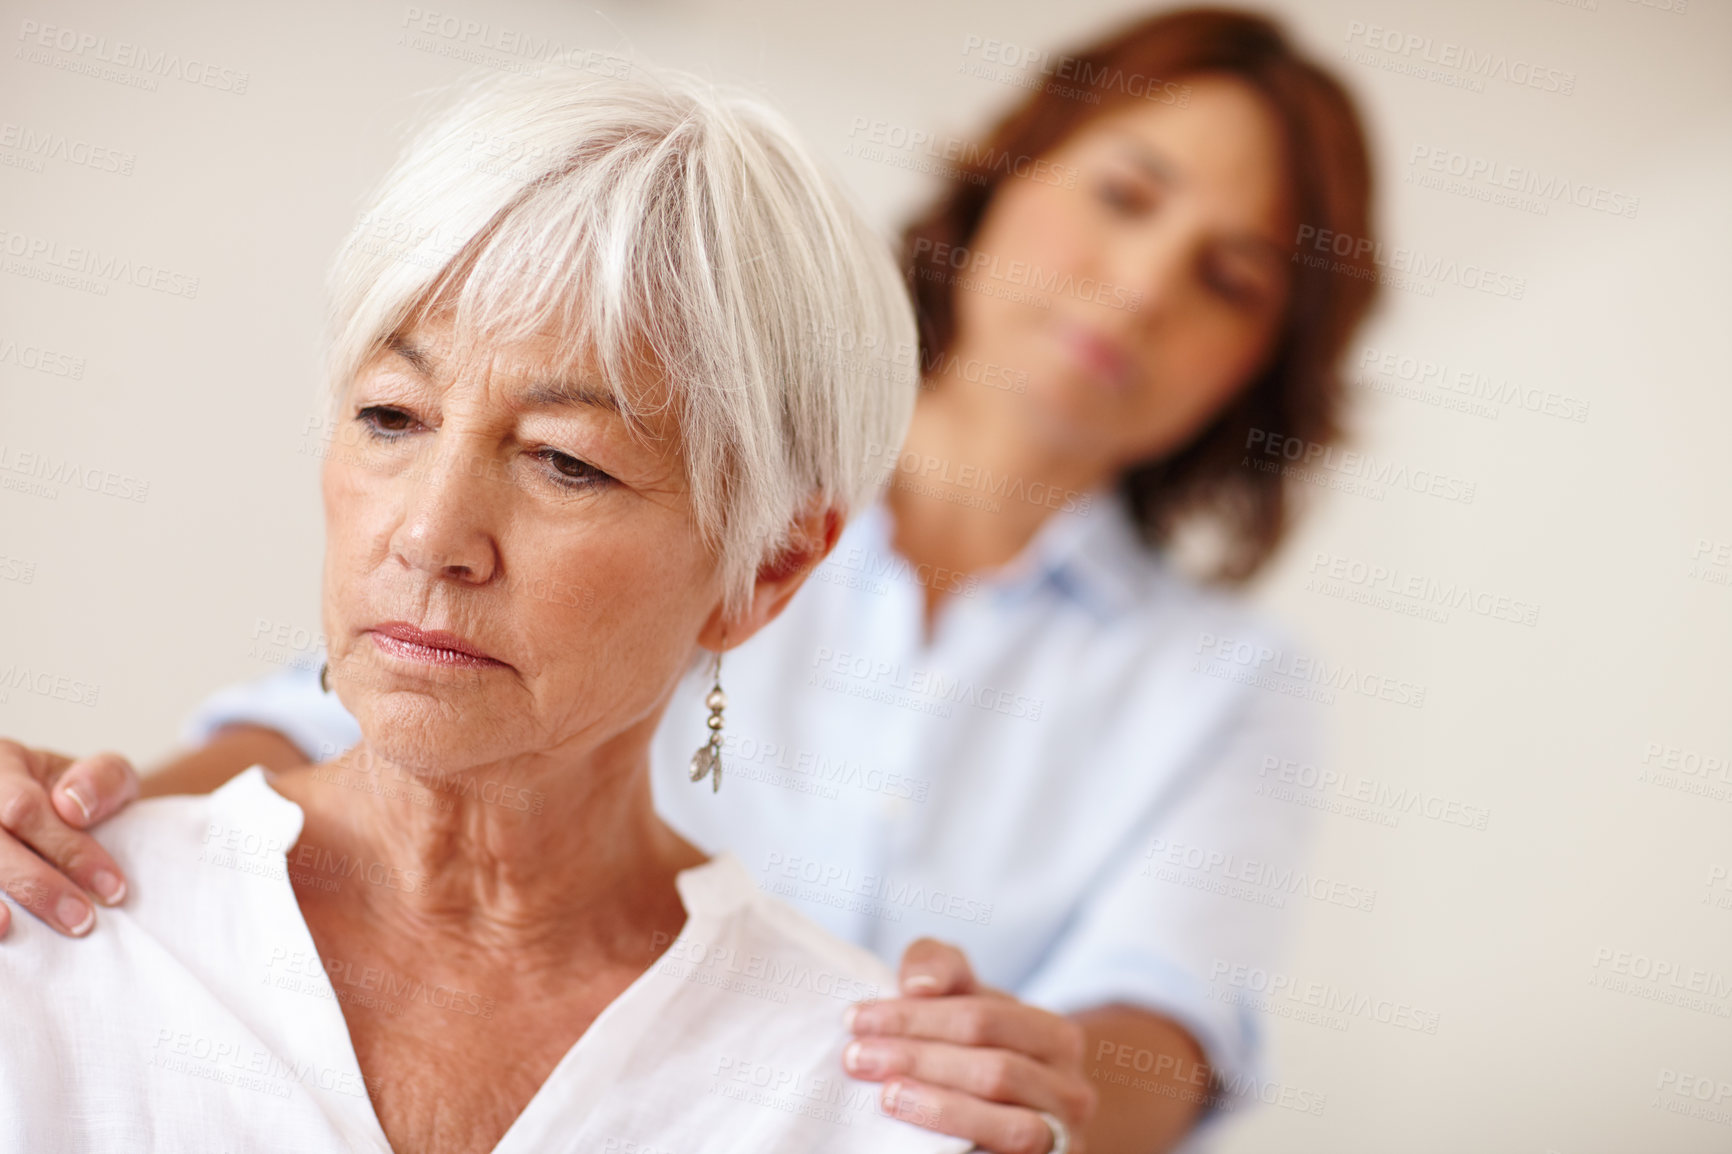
[1018,675,1320,1114]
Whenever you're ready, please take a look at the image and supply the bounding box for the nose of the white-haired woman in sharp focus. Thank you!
[391,445,501,584]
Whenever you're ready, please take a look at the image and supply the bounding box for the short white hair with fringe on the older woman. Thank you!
[331,69,918,610]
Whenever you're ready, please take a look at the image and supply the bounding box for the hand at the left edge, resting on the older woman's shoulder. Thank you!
[0,738,139,937]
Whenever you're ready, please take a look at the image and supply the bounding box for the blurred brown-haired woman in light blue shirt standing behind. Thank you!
[0,10,1373,1154]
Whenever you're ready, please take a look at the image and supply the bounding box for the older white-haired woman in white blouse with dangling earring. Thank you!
[0,78,968,1154]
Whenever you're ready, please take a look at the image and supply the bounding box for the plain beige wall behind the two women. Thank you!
[0,0,1732,1154]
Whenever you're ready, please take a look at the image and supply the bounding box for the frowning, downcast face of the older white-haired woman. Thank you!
[324,321,719,773]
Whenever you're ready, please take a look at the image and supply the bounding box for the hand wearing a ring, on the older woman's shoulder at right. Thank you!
[842,937,1096,1154]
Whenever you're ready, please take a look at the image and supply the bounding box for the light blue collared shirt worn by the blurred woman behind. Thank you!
[187,496,1328,1102]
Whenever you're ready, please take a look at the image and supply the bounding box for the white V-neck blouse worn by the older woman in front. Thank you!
[0,768,972,1154]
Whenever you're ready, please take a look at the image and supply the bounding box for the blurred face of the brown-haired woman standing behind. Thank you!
[954,76,1294,471]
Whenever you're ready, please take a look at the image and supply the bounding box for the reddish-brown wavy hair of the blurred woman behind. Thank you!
[902,9,1375,582]
